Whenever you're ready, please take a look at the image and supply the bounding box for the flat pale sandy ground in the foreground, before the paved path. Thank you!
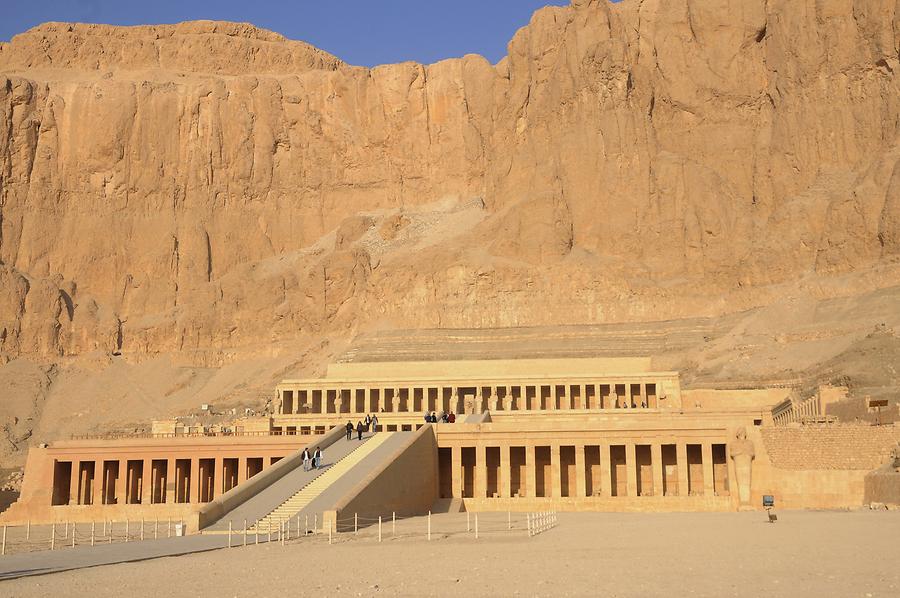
[0,511,900,598]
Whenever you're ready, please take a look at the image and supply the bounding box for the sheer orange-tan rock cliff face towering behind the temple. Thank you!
[0,0,900,364]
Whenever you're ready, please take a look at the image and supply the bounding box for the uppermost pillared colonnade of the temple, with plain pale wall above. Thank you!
[277,358,681,416]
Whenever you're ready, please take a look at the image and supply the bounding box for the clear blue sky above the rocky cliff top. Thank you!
[0,0,569,66]
